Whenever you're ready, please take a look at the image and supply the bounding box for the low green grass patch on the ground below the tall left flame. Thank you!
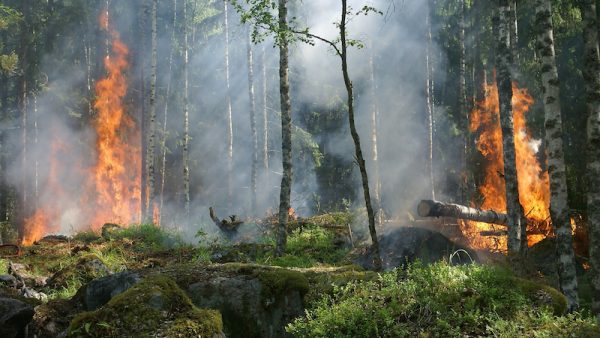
[111,224,184,251]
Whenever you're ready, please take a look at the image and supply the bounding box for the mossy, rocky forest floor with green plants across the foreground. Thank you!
[0,213,600,337]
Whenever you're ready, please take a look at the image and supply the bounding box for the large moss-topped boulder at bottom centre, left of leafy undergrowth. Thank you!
[161,263,309,337]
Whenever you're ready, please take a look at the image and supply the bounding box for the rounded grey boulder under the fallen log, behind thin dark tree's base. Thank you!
[355,227,477,270]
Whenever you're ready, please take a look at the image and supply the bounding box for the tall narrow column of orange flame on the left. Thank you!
[91,13,141,229]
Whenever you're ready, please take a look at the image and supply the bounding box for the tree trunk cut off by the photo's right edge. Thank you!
[581,0,600,319]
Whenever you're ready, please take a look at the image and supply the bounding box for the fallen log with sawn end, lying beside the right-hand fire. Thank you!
[417,200,508,226]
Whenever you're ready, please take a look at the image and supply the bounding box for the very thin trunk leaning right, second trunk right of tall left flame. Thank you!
[158,0,177,225]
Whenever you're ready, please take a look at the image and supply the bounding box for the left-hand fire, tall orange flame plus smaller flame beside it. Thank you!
[22,13,141,245]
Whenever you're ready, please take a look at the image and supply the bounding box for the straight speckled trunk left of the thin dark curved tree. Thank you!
[276,0,292,256]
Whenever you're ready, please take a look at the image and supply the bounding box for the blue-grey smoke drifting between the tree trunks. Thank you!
[7,0,464,241]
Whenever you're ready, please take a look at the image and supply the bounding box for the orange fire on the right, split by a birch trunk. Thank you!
[461,83,551,251]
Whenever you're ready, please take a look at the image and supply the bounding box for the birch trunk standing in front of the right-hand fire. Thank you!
[496,0,527,255]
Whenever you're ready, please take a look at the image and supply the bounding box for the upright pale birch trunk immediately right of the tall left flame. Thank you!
[143,0,158,223]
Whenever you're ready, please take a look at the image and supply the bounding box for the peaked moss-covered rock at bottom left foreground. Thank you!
[67,275,223,337]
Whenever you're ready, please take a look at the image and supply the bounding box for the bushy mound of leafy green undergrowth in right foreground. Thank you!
[287,262,599,337]
